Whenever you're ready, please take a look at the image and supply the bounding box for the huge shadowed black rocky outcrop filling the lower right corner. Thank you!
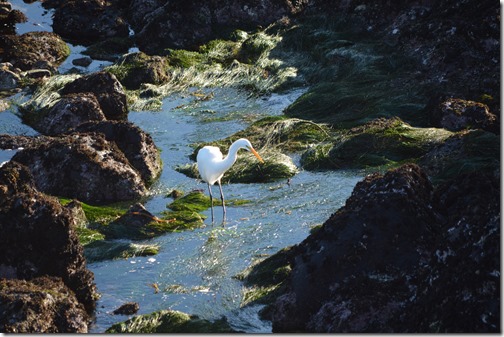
[258,164,500,333]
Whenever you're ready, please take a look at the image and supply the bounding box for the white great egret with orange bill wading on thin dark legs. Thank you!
[196,138,264,223]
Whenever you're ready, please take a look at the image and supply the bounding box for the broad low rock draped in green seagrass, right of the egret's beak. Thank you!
[301,118,452,170]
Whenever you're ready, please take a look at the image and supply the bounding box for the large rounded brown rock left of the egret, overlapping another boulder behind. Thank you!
[12,133,147,204]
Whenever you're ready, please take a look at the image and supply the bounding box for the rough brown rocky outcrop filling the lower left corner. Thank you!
[0,161,97,322]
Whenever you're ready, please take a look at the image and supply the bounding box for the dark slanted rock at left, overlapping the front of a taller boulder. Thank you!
[32,93,106,136]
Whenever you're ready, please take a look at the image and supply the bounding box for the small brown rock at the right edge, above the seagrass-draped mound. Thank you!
[431,98,499,133]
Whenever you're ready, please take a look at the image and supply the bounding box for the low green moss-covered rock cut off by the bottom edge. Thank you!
[105,310,238,333]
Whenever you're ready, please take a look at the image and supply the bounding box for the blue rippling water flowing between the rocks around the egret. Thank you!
[4,0,362,333]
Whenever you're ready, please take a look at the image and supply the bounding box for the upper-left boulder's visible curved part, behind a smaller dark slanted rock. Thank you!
[61,71,128,120]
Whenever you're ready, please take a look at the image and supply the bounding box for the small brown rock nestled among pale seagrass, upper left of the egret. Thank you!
[110,52,169,90]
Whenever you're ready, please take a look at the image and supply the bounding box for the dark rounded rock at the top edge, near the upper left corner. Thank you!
[53,0,129,42]
